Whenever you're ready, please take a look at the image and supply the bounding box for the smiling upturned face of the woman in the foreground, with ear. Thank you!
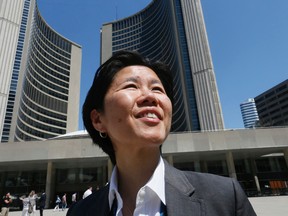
[91,66,172,151]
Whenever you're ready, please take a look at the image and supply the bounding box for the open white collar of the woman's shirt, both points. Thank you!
[108,157,166,209]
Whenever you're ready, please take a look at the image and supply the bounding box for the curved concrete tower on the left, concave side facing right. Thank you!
[0,0,82,142]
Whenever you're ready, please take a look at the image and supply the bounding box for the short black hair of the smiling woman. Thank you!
[82,51,173,165]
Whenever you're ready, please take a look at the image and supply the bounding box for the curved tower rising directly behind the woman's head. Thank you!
[101,0,224,131]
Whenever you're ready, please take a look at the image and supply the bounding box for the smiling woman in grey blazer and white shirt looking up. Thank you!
[67,51,255,216]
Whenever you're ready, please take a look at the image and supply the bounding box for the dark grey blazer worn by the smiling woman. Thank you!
[67,161,256,216]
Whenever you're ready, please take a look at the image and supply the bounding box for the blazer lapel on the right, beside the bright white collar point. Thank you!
[164,161,205,216]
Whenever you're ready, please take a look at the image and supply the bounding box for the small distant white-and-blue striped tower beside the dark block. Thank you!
[240,98,259,128]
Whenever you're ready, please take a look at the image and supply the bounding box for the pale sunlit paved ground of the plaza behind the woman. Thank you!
[9,196,288,216]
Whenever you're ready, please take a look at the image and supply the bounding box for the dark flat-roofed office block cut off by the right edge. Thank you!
[255,79,288,127]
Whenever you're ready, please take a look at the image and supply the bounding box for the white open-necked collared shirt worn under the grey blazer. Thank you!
[109,157,166,216]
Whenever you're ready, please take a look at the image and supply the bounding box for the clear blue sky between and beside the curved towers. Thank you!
[38,0,288,129]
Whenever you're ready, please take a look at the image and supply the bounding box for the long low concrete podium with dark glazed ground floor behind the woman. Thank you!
[0,127,288,207]
